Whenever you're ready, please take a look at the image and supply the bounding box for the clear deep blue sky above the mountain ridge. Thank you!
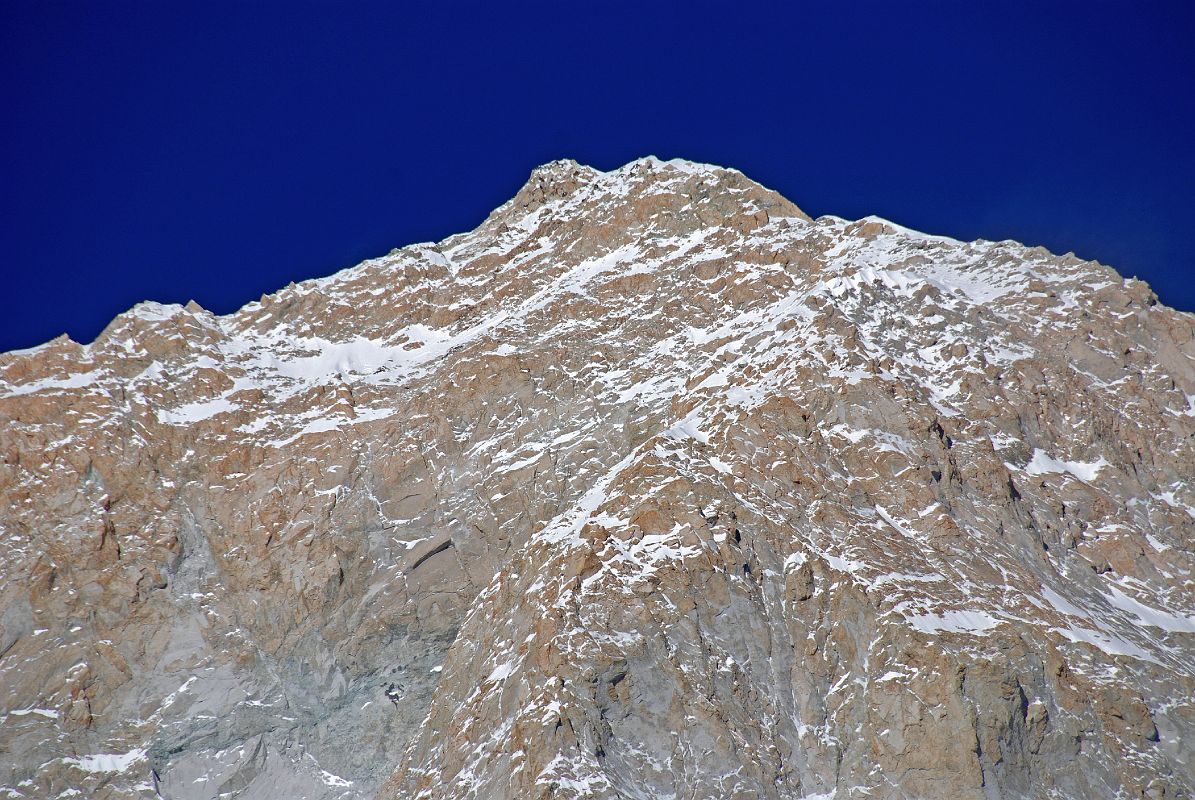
[0,0,1195,349]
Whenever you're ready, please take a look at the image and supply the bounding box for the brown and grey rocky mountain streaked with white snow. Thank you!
[0,159,1195,800]
